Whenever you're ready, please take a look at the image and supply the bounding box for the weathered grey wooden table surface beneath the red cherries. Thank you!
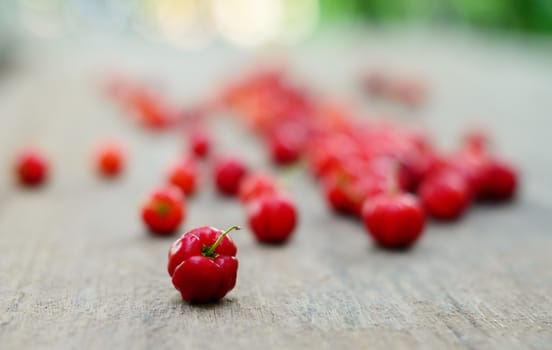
[0,33,552,350]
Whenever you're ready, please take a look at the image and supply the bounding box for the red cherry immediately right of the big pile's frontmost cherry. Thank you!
[418,171,471,220]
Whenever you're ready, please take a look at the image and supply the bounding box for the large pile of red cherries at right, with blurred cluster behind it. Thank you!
[220,71,518,248]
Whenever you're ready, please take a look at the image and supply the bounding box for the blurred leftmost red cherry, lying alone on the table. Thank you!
[15,149,48,186]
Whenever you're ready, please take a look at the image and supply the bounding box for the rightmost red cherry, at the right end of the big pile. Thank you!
[480,160,518,201]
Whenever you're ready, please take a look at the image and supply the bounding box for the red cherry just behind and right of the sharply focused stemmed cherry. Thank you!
[247,194,297,244]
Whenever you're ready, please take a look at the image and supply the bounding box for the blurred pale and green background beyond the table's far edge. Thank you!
[0,0,552,52]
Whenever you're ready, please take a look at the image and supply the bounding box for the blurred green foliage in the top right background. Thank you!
[320,0,552,33]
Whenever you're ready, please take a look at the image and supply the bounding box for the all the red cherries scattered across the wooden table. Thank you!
[12,70,518,302]
